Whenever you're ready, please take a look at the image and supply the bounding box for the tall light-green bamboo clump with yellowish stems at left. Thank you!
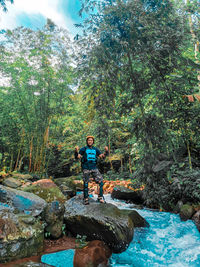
[0,20,73,173]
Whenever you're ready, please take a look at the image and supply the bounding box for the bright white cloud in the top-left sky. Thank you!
[0,0,74,31]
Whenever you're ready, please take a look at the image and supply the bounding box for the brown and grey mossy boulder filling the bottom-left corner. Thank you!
[0,208,44,263]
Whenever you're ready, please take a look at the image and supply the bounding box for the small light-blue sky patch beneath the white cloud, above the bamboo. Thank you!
[16,13,46,30]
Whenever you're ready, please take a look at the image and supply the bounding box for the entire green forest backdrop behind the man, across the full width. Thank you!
[0,0,200,210]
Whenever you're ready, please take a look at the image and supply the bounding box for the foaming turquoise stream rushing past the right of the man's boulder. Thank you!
[106,196,200,267]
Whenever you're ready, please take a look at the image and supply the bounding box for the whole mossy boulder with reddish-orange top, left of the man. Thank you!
[23,179,66,203]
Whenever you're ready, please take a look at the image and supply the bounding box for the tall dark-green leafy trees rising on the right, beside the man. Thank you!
[73,0,200,210]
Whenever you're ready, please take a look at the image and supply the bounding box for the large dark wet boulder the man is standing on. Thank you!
[64,195,134,253]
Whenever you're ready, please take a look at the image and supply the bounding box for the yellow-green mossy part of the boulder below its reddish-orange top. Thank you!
[23,184,66,203]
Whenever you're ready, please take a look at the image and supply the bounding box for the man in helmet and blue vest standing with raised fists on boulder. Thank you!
[75,136,108,205]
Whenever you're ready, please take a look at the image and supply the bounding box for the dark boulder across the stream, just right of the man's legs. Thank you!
[111,186,144,204]
